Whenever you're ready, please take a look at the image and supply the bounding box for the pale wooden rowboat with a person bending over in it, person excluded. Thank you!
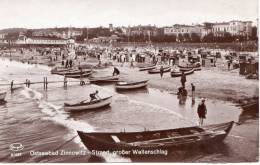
[64,96,112,112]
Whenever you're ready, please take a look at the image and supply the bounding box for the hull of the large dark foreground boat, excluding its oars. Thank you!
[78,121,234,156]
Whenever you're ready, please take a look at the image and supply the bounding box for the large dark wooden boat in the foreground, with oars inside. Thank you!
[78,121,234,156]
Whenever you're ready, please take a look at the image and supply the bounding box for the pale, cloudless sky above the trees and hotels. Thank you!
[0,0,258,29]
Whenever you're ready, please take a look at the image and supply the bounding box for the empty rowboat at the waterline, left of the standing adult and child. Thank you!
[115,80,149,90]
